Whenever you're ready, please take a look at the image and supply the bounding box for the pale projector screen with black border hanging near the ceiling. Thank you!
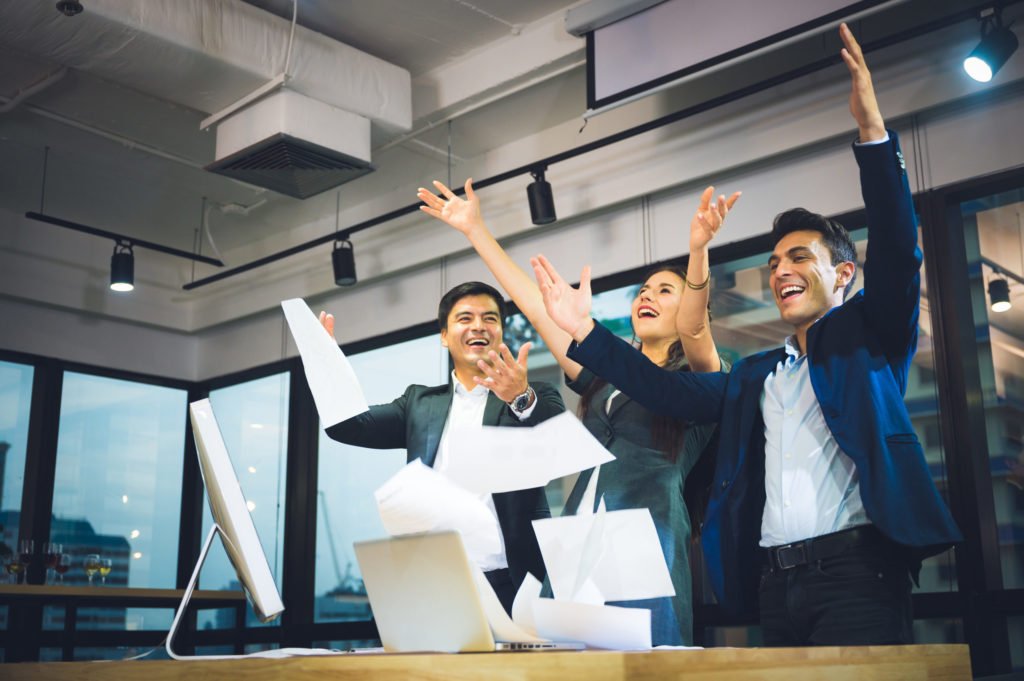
[587,0,891,110]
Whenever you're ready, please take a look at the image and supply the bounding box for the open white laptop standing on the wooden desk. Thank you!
[354,531,584,652]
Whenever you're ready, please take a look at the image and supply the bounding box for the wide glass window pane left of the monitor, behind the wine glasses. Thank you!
[50,372,187,629]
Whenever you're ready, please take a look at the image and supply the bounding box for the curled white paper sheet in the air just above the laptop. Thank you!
[374,459,502,564]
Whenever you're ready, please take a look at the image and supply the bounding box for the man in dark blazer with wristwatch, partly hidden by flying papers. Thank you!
[321,282,565,613]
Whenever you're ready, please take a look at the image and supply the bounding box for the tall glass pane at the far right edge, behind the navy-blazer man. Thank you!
[961,189,1024,589]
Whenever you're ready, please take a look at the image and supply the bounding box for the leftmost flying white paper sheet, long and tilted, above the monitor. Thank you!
[281,298,370,428]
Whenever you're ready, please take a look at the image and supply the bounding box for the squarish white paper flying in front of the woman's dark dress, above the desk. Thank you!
[534,507,676,602]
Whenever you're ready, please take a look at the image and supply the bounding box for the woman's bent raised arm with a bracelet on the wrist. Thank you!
[676,186,739,372]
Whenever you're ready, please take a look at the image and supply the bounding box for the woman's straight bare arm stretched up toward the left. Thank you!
[416,179,582,380]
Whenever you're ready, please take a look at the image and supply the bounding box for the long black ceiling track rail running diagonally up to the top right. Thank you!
[181,0,1024,291]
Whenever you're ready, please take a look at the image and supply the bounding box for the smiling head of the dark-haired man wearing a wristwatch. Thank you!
[441,294,502,374]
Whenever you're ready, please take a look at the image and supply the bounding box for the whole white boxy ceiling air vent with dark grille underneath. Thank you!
[206,90,374,199]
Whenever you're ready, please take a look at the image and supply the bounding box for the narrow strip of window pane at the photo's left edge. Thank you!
[0,361,33,578]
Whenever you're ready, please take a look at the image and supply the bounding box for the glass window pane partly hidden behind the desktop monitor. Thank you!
[199,372,290,629]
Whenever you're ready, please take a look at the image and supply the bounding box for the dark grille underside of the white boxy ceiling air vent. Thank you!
[206,133,374,199]
